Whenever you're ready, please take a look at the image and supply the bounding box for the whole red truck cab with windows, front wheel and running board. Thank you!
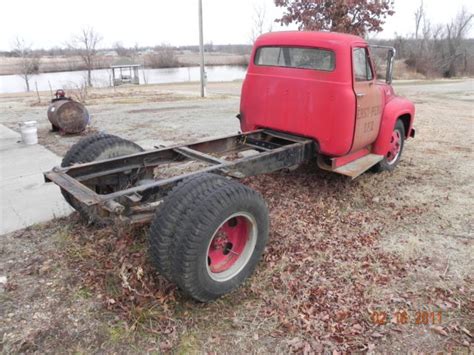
[239,32,415,177]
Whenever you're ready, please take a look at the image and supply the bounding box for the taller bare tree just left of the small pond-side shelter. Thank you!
[70,27,102,86]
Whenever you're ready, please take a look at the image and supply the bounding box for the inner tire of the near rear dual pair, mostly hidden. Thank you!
[150,173,230,281]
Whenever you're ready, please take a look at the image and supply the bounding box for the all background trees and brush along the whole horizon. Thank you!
[5,0,474,91]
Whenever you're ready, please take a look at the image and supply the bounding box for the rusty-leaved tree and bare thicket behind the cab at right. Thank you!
[268,0,474,78]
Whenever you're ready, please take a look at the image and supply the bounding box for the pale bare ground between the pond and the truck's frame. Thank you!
[0,82,241,156]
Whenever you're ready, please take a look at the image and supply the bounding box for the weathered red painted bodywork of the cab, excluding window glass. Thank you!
[240,32,414,161]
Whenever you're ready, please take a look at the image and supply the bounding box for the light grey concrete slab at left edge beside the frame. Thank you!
[0,125,72,235]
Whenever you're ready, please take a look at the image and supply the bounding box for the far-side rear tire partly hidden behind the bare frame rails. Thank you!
[61,135,143,222]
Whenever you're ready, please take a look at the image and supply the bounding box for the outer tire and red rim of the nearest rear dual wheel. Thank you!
[171,182,269,302]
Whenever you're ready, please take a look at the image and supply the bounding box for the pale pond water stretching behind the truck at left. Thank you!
[0,65,247,93]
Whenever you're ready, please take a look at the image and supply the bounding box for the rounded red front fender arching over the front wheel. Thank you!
[372,97,415,155]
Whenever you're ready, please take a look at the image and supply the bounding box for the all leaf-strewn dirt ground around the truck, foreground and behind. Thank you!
[0,80,474,354]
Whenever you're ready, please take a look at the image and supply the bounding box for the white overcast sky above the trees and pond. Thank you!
[0,0,474,50]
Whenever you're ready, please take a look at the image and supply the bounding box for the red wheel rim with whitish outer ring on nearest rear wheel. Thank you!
[207,212,257,281]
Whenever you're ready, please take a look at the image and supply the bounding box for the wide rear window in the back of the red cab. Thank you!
[254,46,336,71]
